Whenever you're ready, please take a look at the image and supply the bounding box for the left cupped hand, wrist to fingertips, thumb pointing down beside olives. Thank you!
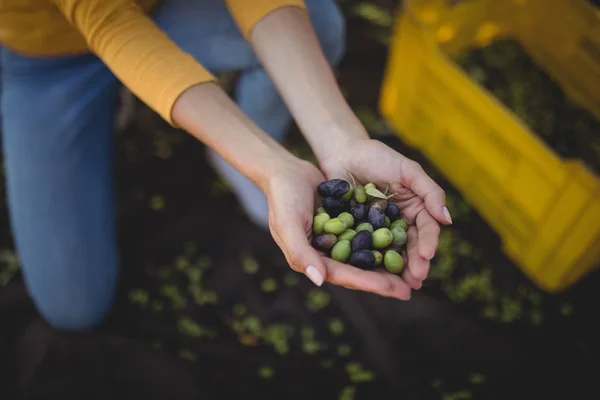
[265,156,411,300]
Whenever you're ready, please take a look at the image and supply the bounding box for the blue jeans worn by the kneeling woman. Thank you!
[0,0,345,330]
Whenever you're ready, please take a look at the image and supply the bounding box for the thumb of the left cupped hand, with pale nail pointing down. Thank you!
[281,225,327,286]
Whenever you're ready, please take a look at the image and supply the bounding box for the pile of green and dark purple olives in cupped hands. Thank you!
[312,179,407,274]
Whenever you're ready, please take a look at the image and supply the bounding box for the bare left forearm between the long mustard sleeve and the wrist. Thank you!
[172,83,298,191]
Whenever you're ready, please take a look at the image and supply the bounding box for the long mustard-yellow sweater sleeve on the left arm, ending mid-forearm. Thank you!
[54,0,216,126]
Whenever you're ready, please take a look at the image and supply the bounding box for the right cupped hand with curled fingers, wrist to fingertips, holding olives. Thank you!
[321,139,452,289]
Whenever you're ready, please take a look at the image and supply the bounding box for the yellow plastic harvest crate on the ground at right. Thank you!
[380,0,600,292]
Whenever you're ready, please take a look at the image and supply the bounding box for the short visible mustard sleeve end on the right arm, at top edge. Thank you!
[225,0,306,39]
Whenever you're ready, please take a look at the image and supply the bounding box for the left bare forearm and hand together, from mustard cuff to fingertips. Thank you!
[173,84,418,299]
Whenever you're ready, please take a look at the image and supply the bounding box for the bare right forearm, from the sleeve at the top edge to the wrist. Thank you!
[250,7,368,161]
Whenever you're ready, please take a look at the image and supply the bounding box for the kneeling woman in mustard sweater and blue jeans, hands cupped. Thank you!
[0,0,451,330]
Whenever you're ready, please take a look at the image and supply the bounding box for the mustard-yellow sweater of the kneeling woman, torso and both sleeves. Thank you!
[0,0,306,125]
